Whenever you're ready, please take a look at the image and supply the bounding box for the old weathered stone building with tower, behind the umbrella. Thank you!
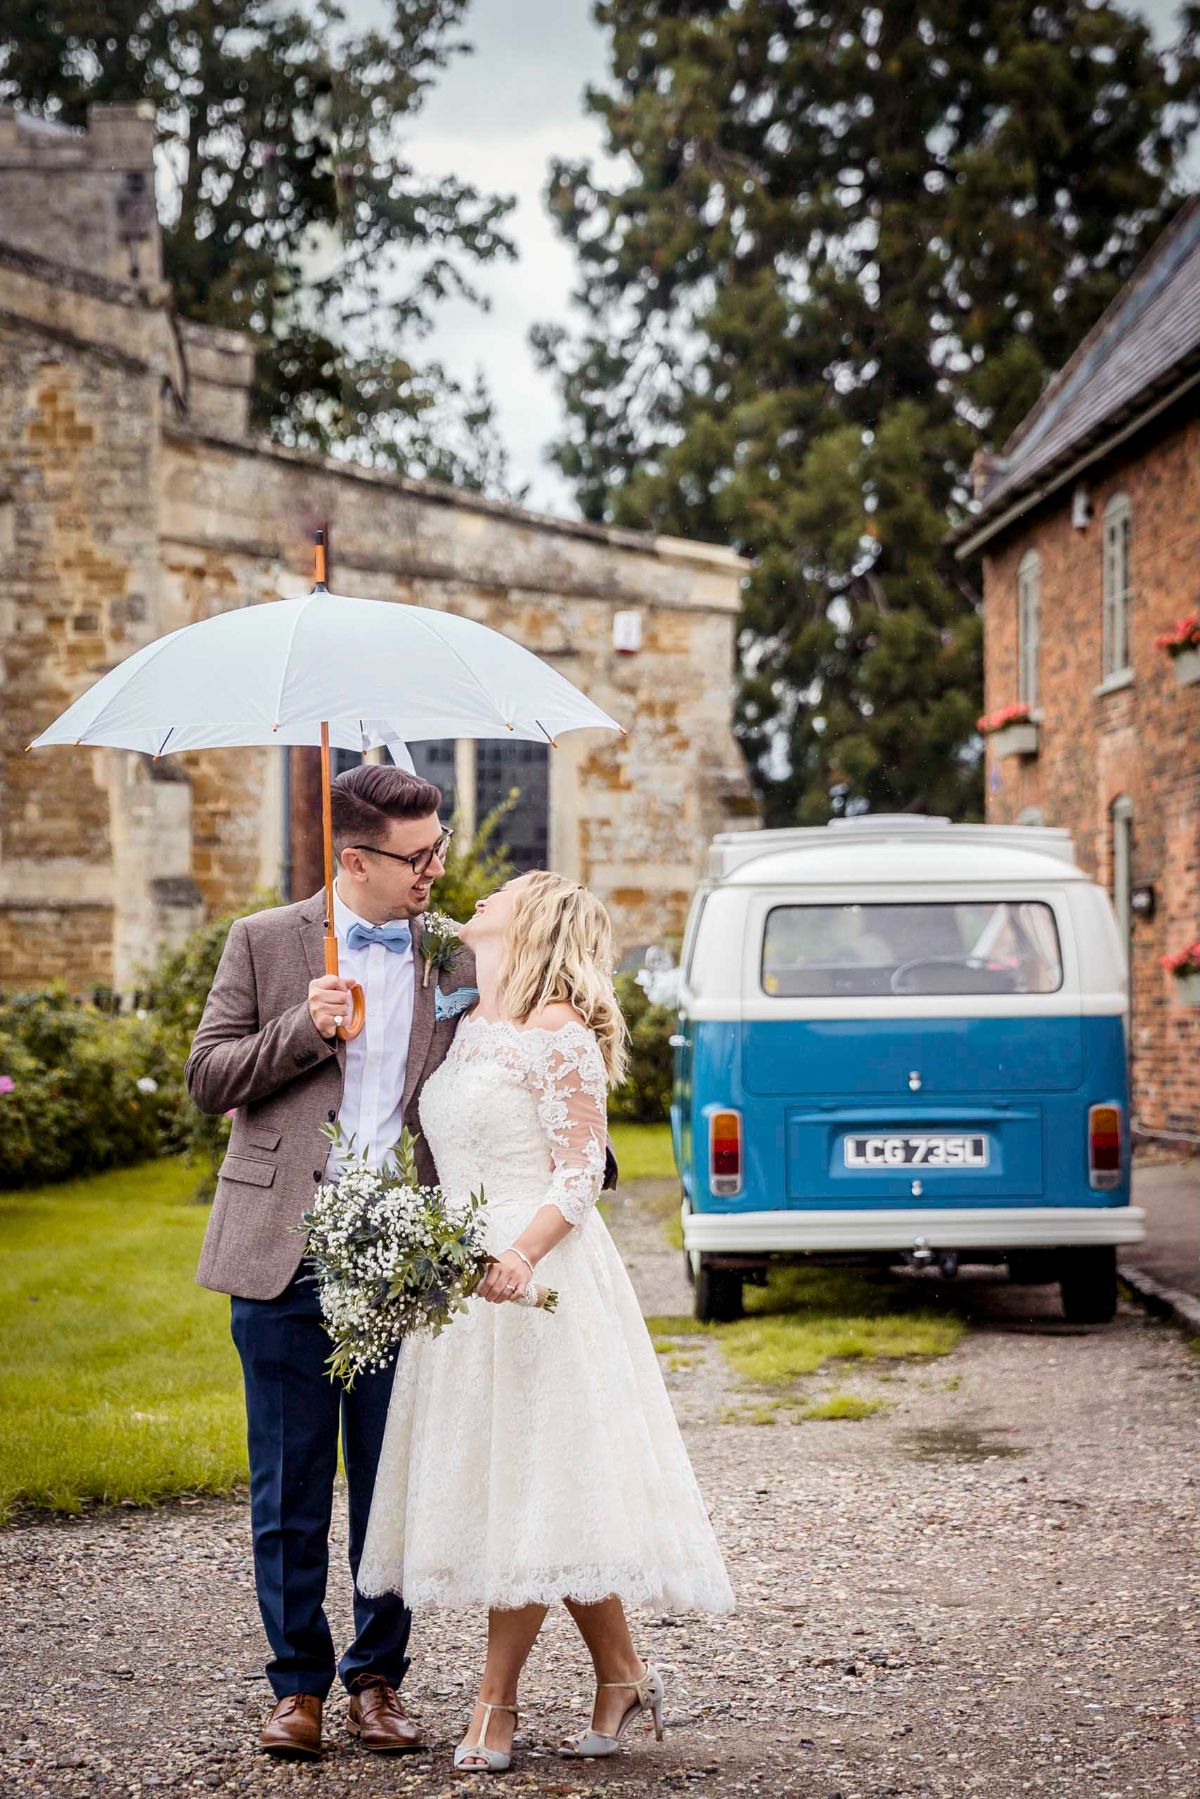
[0,106,748,989]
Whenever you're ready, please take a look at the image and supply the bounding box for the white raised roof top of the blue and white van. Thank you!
[709,813,1088,887]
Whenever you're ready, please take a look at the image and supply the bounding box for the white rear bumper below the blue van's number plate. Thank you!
[684,1205,1146,1256]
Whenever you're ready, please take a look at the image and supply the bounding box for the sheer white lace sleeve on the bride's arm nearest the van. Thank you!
[529,1024,608,1225]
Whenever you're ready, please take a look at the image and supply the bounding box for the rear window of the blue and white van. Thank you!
[763,900,1063,998]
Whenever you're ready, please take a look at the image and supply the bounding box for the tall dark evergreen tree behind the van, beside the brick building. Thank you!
[534,0,1200,822]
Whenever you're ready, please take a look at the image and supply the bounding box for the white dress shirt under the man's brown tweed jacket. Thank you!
[326,887,416,1180]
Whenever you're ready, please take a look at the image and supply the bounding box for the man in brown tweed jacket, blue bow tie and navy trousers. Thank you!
[185,765,475,1758]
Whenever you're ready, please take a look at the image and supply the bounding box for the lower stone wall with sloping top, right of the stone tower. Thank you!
[162,426,748,944]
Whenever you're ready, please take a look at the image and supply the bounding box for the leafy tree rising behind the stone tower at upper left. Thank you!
[0,0,513,489]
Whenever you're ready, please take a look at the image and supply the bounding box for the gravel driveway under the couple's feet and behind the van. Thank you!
[0,1189,1200,1799]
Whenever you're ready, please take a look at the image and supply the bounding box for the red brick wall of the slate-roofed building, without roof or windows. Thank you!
[984,419,1200,1133]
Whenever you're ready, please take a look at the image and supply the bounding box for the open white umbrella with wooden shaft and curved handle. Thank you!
[29,540,622,1036]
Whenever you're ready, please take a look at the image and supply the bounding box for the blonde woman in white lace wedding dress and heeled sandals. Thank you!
[358,873,734,1772]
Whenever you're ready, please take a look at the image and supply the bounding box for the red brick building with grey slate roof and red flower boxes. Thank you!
[957,200,1200,1137]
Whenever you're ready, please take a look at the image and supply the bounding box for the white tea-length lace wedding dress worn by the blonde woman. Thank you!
[358,1018,734,1612]
